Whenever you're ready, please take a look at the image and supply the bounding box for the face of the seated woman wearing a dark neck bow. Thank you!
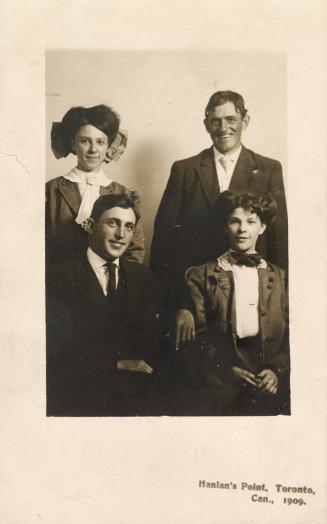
[226,207,266,253]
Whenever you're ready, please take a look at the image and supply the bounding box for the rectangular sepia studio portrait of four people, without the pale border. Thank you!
[45,50,291,417]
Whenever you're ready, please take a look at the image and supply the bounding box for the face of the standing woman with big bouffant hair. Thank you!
[72,124,108,171]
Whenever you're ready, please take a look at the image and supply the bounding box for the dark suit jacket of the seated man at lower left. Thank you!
[46,255,160,416]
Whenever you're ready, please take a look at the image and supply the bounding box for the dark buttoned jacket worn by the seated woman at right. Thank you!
[186,260,289,375]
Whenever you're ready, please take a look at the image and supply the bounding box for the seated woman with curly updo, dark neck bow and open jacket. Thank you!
[179,191,289,415]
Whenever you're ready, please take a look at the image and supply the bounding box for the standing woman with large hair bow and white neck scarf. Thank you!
[45,104,144,264]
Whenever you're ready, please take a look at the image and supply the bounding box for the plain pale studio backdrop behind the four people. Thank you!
[46,50,287,262]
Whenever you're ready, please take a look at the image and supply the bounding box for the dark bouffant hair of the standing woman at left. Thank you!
[51,104,120,162]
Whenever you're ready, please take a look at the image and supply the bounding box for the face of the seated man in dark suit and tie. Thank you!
[89,207,136,261]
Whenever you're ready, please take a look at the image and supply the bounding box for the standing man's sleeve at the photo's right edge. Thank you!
[267,160,288,269]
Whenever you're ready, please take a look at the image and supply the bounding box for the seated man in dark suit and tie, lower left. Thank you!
[46,195,160,416]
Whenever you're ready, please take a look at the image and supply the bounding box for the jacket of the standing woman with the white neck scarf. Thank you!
[45,176,144,264]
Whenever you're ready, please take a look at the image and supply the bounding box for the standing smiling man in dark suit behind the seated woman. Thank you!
[150,91,288,293]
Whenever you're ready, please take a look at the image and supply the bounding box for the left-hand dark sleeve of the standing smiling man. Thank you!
[150,162,184,279]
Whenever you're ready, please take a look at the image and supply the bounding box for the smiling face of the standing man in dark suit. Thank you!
[204,101,250,154]
